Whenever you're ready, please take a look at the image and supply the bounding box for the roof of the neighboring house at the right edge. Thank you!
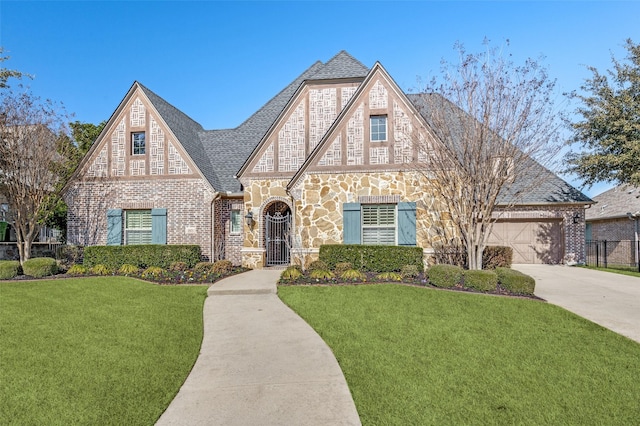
[585,185,640,220]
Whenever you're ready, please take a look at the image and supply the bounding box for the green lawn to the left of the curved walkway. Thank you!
[0,277,207,425]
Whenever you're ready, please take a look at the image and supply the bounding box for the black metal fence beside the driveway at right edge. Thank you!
[586,240,640,272]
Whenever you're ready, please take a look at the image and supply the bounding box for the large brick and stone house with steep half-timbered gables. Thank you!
[65,52,591,268]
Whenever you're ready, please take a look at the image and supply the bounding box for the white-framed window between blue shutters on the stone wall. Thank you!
[362,204,396,246]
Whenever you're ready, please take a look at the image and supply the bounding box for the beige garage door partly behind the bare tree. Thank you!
[487,220,564,264]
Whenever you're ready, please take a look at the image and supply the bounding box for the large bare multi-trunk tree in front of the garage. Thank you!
[411,43,562,269]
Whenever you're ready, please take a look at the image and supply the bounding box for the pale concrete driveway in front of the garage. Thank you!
[512,265,640,343]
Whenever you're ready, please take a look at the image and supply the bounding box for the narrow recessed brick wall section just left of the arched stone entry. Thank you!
[213,198,245,265]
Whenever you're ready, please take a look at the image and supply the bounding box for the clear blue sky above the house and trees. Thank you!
[0,0,640,196]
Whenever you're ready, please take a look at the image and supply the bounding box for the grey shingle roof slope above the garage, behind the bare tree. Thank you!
[407,94,592,204]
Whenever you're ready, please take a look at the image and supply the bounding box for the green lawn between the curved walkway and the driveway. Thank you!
[278,285,640,425]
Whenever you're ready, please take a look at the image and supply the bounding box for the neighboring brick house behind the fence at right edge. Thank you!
[585,185,640,264]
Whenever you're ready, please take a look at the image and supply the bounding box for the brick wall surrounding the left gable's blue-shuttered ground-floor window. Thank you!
[65,178,214,259]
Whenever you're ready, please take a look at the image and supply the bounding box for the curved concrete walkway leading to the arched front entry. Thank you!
[156,270,360,426]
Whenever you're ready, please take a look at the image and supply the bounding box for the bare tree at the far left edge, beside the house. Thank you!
[0,90,71,263]
